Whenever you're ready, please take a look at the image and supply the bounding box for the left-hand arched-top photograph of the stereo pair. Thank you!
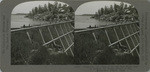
[11,1,74,65]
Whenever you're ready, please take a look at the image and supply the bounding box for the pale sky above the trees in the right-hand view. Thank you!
[75,1,130,15]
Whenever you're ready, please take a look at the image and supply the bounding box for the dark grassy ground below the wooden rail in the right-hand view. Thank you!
[74,24,139,65]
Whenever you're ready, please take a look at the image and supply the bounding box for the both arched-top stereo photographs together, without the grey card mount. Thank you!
[11,1,140,65]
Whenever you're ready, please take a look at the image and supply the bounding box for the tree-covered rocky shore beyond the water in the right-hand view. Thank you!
[92,2,138,23]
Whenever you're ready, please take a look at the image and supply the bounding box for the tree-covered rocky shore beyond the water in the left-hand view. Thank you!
[26,2,74,22]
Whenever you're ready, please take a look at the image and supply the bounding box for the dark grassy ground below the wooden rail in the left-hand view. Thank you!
[11,22,74,65]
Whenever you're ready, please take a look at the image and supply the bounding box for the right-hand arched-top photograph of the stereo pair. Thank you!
[74,1,140,65]
